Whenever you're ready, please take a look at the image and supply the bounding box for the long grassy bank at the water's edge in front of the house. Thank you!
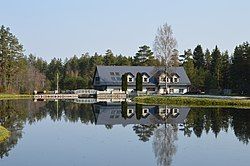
[134,96,250,108]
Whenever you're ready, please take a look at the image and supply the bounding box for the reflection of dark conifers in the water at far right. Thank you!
[184,108,250,144]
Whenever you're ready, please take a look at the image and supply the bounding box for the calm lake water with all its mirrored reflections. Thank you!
[0,100,250,166]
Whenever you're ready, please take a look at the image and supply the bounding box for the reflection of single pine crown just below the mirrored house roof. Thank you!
[133,124,156,142]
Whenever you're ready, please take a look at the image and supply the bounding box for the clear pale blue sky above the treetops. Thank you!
[0,0,250,60]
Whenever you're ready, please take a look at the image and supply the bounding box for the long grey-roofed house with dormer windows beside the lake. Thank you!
[93,66,191,94]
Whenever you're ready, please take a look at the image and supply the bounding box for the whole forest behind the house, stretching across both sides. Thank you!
[0,26,250,95]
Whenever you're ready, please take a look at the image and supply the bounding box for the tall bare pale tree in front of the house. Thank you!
[154,23,178,93]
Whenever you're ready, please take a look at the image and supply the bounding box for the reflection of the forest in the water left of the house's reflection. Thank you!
[0,100,94,158]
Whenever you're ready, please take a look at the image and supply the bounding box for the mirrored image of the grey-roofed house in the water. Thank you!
[93,103,190,126]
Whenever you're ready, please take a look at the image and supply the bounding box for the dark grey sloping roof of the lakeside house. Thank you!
[96,66,191,85]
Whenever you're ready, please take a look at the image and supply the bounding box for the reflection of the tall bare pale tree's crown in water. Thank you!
[153,124,177,166]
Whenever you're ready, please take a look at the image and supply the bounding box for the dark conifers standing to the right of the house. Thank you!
[180,42,250,95]
